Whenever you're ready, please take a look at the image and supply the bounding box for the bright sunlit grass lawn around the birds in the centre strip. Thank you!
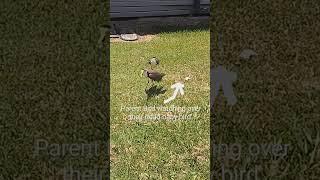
[110,30,210,180]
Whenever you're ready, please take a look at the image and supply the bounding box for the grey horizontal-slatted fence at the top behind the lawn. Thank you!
[110,0,210,18]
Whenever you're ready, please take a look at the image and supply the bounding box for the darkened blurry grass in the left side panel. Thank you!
[0,0,109,180]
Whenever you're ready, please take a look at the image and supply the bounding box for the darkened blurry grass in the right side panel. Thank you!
[211,1,320,179]
